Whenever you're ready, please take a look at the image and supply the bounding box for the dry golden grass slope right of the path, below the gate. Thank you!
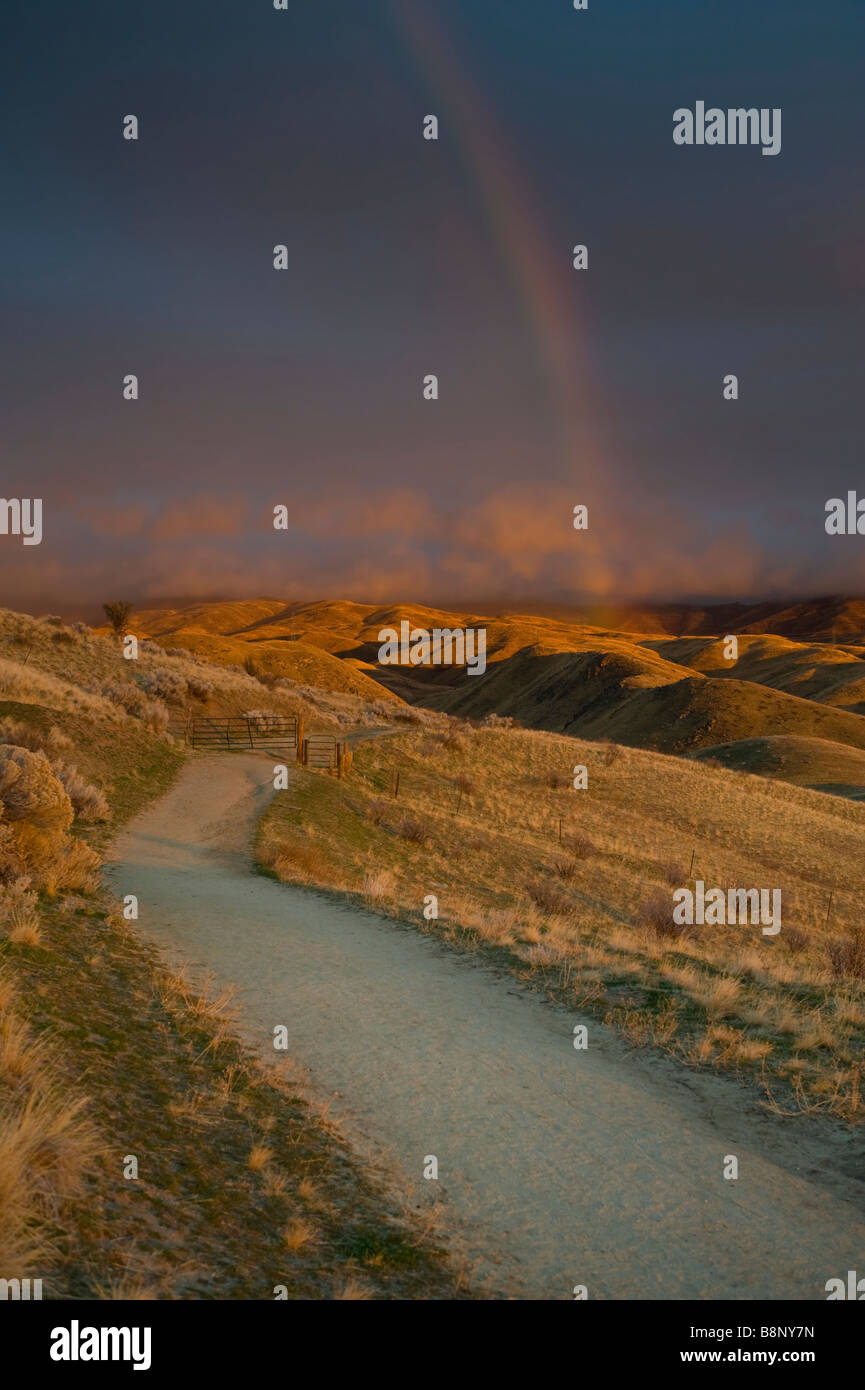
[259,722,865,1122]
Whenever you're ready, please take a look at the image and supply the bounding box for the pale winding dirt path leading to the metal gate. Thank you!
[108,755,865,1300]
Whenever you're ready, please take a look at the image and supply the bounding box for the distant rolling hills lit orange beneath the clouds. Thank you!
[128,599,865,787]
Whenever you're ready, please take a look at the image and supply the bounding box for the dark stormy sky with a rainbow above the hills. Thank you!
[0,0,865,616]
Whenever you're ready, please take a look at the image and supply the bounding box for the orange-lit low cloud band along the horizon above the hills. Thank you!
[0,484,865,622]
